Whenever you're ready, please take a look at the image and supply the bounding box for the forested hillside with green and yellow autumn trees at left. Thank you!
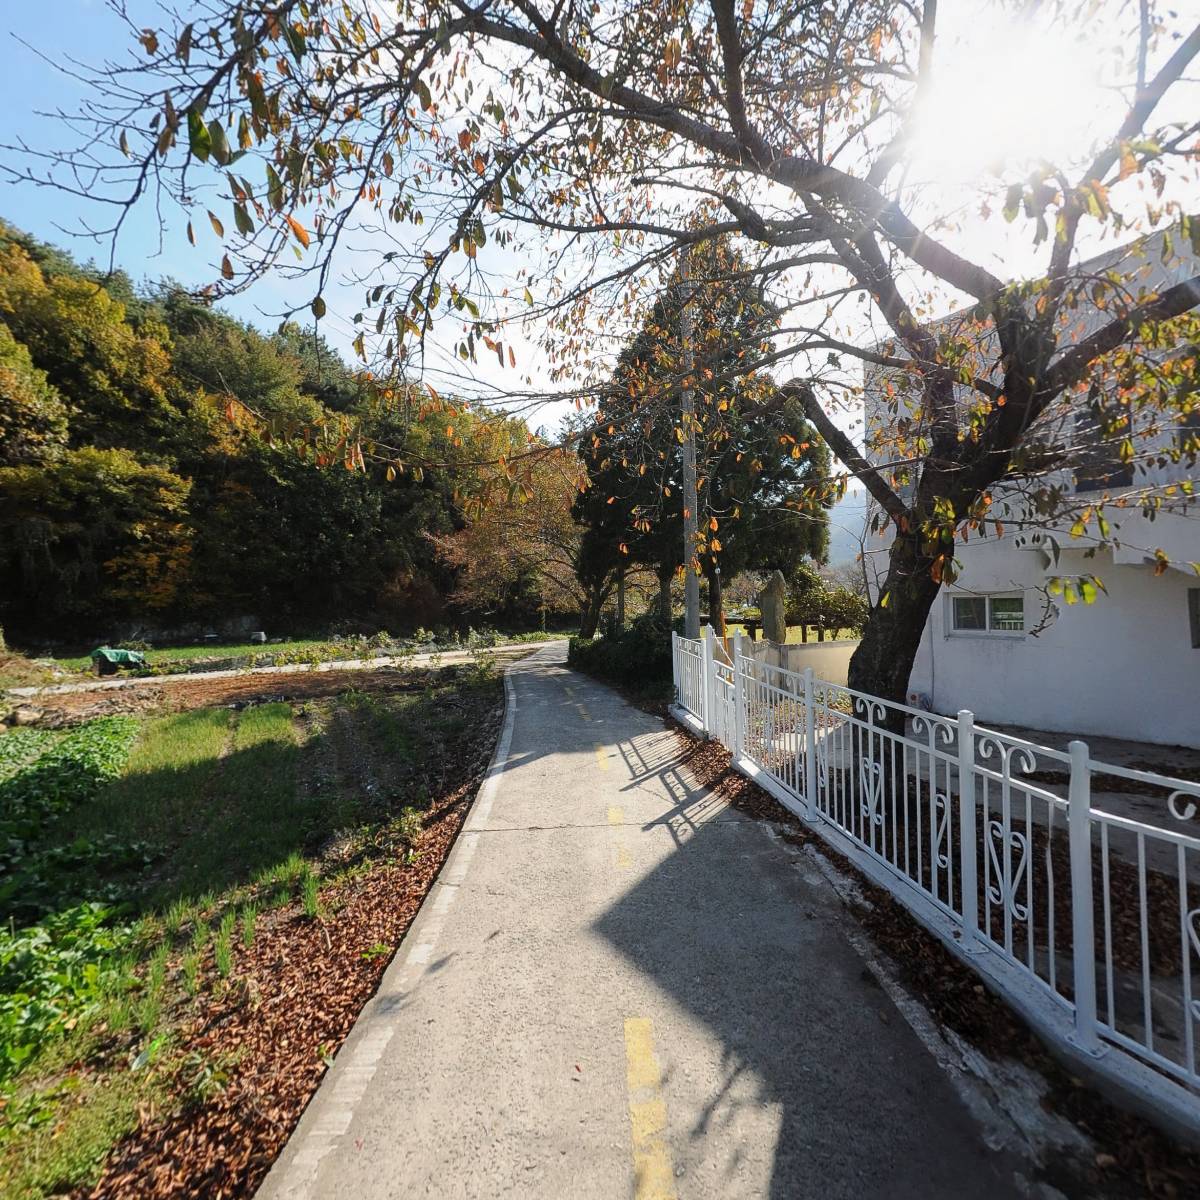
[0,223,536,644]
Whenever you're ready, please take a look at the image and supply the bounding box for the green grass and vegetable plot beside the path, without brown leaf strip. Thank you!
[0,664,503,1200]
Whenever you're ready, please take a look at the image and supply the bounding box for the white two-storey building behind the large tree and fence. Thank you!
[866,236,1200,748]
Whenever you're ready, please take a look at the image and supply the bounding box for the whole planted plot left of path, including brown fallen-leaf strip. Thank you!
[0,666,502,1200]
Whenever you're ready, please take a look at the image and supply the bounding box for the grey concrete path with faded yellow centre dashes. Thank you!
[259,647,1021,1200]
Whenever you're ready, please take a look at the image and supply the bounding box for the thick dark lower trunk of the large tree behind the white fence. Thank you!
[848,536,941,732]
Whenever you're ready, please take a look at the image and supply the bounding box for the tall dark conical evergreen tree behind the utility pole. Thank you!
[574,242,832,625]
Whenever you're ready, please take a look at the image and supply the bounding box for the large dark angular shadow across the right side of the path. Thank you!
[595,768,1013,1200]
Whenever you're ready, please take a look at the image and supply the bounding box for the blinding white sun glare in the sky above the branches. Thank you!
[910,13,1114,185]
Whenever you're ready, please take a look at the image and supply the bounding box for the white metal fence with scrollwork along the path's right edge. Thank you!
[672,630,1200,1129]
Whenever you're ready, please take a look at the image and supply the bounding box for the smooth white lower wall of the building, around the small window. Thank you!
[908,538,1200,748]
